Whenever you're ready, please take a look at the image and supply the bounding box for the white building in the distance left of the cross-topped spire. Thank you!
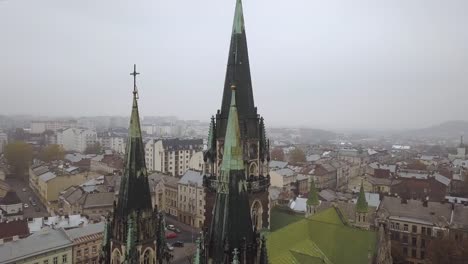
[57,128,97,152]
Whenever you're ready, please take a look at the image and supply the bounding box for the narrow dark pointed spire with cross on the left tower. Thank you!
[117,65,152,216]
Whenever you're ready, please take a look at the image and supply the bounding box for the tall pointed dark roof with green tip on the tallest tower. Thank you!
[221,0,256,118]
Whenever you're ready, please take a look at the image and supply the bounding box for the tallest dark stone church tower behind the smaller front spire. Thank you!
[204,0,270,236]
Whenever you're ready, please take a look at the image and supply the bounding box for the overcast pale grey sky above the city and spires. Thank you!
[0,0,468,129]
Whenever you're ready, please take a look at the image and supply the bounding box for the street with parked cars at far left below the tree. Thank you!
[5,178,49,218]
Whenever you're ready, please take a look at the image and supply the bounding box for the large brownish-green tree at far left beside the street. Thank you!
[4,141,33,179]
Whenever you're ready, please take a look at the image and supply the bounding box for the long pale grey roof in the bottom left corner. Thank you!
[0,229,73,264]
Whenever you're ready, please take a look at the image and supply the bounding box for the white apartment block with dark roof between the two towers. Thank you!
[145,138,203,177]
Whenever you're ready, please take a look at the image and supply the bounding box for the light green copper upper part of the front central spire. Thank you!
[221,86,244,174]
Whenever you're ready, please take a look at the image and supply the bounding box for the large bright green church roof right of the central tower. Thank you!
[267,208,377,264]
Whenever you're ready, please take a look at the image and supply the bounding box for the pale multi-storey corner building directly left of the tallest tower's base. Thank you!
[178,170,205,228]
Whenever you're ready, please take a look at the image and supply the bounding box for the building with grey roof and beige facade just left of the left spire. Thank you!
[65,222,104,264]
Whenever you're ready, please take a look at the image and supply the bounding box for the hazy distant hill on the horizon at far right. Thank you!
[401,121,468,139]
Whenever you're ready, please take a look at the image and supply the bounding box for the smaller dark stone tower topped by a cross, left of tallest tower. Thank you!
[99,67,167,264]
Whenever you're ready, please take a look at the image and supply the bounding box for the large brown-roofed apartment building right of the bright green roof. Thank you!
[377,197,468,264]
